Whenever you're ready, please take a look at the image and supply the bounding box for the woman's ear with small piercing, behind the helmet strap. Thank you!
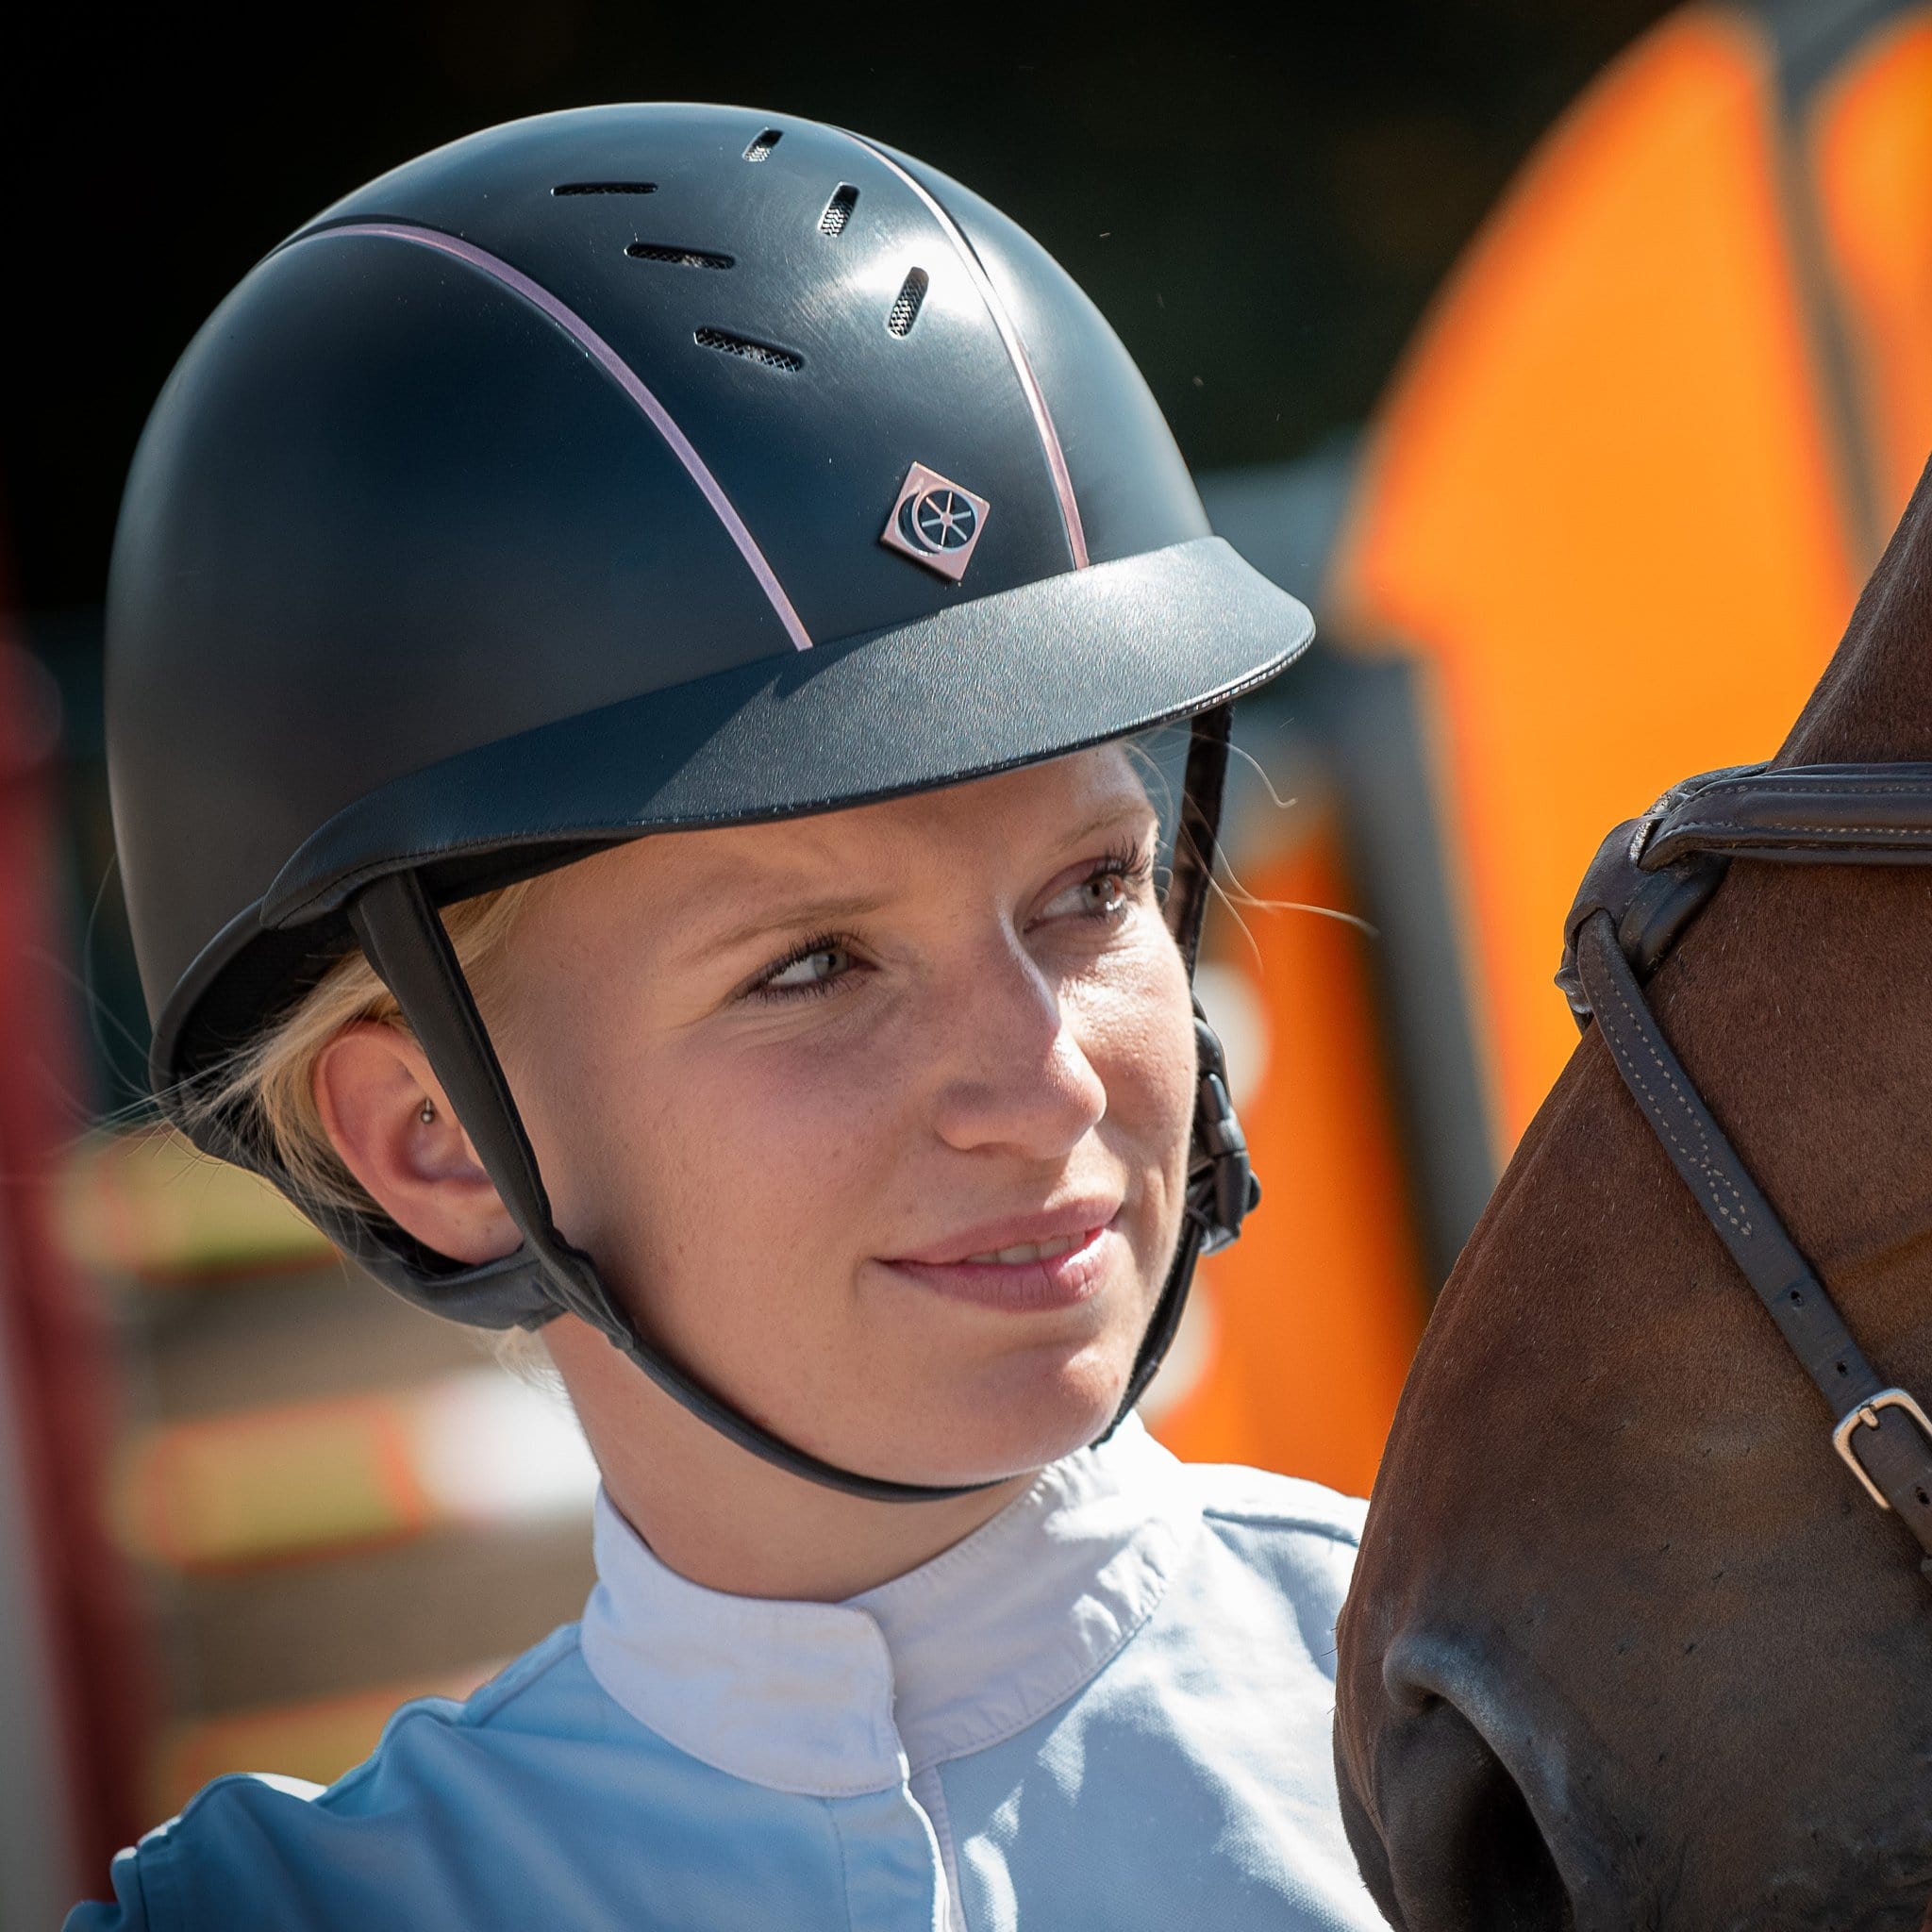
[315,1020,522,1263]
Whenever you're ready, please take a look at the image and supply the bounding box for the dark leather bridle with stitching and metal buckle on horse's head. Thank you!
[1557,763,1932,1578]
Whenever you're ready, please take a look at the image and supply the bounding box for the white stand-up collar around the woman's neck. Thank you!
[581,1418,1200,1797]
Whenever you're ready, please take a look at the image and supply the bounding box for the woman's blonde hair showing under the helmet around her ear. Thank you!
[182,879,537,1221]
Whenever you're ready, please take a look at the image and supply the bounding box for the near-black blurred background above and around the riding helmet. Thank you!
[11,0,1665,614]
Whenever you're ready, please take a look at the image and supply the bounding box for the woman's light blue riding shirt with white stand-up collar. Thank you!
[66,1422,1381,1932]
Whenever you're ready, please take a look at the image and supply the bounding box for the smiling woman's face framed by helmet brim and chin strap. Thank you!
[491,746,1194,1482]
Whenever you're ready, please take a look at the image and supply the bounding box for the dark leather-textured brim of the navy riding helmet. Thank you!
[153,537,1314,1091]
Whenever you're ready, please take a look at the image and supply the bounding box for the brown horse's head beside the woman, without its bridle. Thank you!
[1335,456,1932,1932]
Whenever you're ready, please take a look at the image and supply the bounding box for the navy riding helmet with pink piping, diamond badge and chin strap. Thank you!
[108,105,1312,1501]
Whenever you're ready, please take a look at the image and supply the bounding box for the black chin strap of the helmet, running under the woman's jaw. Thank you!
[350,706,1259,1503]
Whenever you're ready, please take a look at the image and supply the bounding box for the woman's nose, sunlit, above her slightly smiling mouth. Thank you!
[935,944,1108,1159]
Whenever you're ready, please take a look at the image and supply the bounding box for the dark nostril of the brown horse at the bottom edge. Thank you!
[1377,1698,1576,1932]
